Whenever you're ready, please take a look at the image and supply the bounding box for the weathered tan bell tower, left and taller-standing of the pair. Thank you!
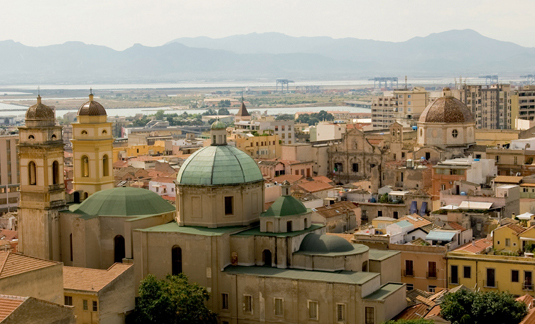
[18,96,65,261]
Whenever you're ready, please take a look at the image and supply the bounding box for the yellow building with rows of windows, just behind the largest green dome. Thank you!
[229,134,282,159]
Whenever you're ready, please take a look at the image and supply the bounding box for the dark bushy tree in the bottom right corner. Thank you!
[440,290,528,324]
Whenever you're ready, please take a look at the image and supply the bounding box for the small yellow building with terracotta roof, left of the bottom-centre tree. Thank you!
[63,263,136,324]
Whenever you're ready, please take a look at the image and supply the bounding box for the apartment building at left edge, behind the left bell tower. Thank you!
[0,135,20,213]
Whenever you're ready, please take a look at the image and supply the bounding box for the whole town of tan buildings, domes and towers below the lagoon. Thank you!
[0,79,535,324]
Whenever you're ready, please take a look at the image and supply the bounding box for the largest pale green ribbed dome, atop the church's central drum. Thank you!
[177,145,264,186]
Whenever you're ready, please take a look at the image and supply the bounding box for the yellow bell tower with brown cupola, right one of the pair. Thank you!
[71,91,113,199]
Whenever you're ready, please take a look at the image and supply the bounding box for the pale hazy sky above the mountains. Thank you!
[0,0,535,50]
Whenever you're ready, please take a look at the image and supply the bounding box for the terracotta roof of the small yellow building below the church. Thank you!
[63,263,132,292]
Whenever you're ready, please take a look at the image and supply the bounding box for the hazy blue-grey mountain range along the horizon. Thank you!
[0,30,535,84]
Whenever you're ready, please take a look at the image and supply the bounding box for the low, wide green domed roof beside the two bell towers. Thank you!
[74,187,175,216]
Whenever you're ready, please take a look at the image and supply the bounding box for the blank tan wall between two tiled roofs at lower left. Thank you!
[0,263,64,305]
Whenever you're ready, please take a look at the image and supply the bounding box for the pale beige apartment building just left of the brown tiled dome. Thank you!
[371,87,429,129]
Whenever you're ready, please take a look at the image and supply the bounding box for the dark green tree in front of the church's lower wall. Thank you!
[132,273,217,324]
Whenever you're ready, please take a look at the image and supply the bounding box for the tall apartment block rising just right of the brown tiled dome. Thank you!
[453,84,512,129]
